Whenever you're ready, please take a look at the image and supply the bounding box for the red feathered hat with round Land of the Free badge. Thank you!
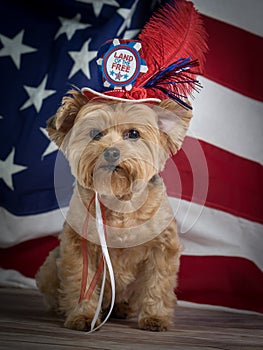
[81,0,207,108]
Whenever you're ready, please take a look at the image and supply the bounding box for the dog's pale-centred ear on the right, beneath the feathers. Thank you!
[157,99,192,154]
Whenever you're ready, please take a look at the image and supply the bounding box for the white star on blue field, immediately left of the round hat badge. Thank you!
[69,39,97,79]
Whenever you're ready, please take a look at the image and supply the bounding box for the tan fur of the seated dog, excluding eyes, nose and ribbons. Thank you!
[36,90,192,331]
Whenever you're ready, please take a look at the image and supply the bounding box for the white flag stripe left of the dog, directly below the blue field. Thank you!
[0,207,67,248]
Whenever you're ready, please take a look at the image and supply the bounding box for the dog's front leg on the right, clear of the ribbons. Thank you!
[139,224,181,331]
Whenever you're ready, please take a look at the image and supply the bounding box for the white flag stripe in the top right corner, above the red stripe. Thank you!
[192,0,263,36]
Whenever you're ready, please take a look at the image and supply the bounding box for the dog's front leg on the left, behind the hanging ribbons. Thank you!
[58,224,100,331]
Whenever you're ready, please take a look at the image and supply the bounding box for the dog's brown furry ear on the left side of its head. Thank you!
[47,90,88,147]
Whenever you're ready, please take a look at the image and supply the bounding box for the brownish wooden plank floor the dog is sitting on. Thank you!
[0,288,263,350]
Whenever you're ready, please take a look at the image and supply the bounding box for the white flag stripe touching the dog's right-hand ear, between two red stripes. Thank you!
[188,77,263,164]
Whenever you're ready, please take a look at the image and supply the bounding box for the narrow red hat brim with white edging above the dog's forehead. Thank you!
[81,87,162,104]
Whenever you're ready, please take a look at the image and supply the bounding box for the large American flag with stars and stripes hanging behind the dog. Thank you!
[0,0,263,312]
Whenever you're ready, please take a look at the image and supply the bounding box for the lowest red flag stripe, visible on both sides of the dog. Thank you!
[0,236,263,312]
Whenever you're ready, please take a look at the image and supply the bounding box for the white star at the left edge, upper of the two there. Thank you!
[0,30,37,69]
